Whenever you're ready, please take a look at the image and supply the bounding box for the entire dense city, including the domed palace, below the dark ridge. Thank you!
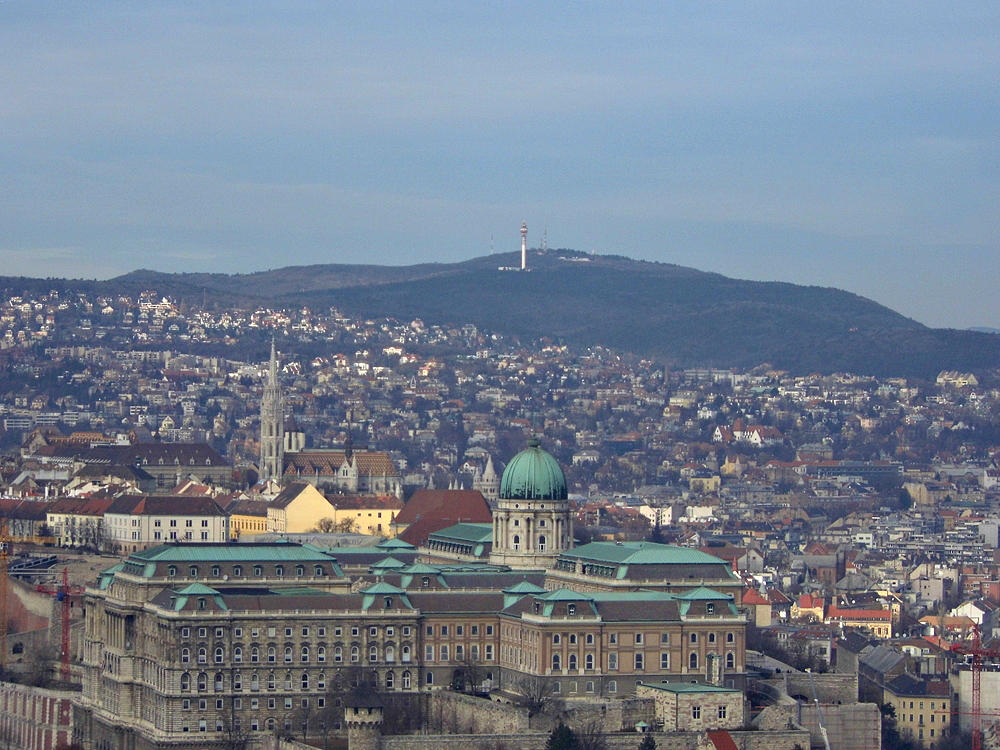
[0,290,1000,750]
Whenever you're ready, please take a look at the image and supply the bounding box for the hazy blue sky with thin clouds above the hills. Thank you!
[0,0,1000,328]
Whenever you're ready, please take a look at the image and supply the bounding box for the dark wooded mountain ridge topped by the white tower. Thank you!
[0,250,1000,378]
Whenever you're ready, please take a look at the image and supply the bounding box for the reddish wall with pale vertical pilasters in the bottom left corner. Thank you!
[0,682,76,750]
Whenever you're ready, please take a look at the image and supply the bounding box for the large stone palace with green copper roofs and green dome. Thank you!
[74,443,746,750]
